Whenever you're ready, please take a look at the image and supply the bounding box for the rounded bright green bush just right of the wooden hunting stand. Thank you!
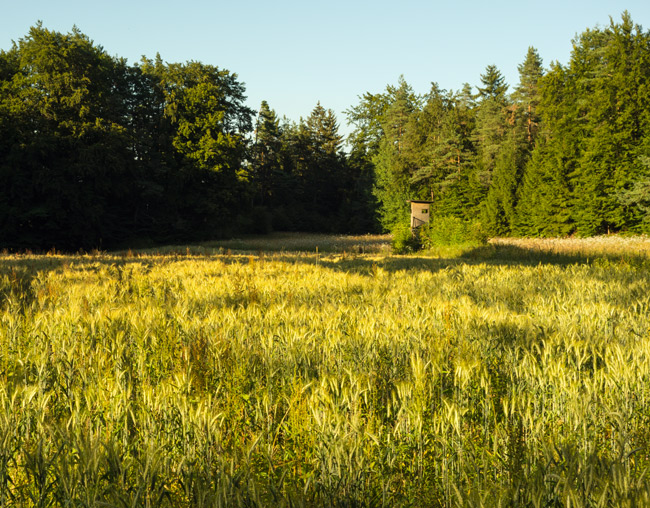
[420,216,488,249]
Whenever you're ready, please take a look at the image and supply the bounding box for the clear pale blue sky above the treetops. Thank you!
[0,0,650,137]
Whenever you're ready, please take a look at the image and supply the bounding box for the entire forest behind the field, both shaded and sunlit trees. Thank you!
[0,12,650,250]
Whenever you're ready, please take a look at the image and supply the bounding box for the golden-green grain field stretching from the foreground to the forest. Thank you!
[0,235,650,507]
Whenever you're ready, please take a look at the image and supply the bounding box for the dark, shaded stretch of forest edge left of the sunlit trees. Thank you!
[0,24,374,250]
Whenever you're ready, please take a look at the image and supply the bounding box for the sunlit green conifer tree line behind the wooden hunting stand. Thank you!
[347,12,650,236]
